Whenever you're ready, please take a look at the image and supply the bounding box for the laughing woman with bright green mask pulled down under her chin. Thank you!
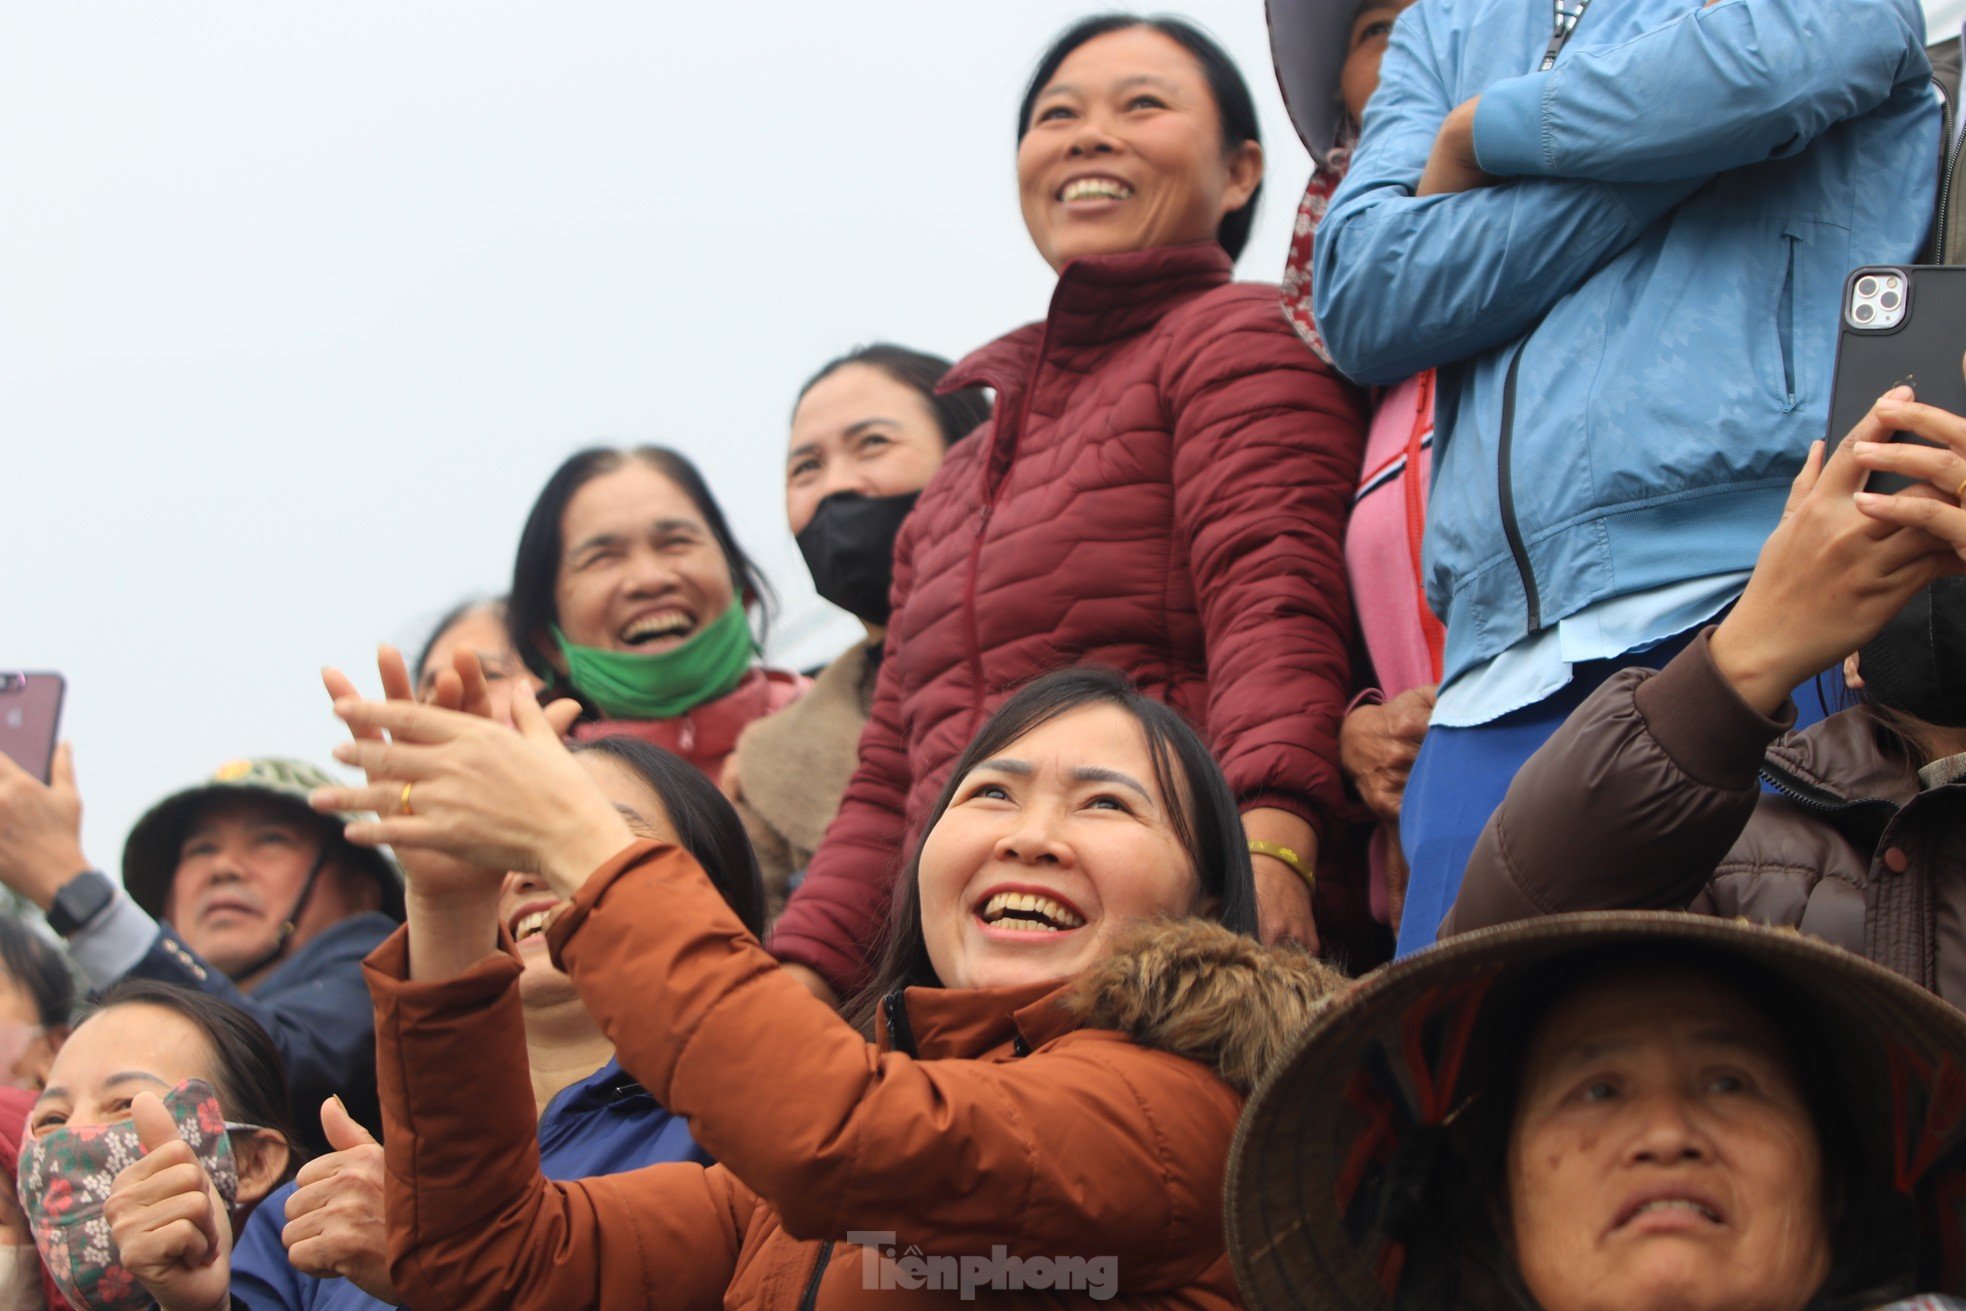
[505,446,808,778]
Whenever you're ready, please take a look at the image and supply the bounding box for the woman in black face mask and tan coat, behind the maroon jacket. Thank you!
[723,344,989,914]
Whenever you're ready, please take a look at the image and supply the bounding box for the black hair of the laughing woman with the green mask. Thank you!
[505,446,775,706]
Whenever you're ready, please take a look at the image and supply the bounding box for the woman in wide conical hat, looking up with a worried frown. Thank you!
[1229,912,1966,1311]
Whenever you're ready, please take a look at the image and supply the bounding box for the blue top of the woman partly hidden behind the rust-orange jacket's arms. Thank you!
[232,1061,710,1311]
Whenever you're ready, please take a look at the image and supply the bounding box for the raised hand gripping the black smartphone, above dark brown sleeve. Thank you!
[1712,387,1962,715]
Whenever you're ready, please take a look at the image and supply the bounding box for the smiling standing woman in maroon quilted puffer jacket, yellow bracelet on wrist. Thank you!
[771,16,1364,995]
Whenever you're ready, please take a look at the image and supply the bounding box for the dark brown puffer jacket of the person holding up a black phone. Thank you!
[1441,629,1966,1006]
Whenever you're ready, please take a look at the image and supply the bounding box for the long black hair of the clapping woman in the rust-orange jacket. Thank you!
[847,664,1256,1032]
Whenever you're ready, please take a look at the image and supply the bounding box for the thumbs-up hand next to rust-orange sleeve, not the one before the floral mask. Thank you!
[279,1097,401,1307]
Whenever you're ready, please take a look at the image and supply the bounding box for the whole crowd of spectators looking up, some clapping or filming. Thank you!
[0,0,1966,1311]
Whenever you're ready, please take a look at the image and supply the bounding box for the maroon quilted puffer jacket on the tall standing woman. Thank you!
[771,242,1366,995]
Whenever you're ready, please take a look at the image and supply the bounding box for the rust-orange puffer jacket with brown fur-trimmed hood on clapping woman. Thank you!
[368,843,1341,1311]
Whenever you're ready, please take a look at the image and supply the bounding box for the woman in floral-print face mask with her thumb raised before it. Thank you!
[20,981,295,1311]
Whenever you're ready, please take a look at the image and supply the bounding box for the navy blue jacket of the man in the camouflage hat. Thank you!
[126,912,395,1152]
